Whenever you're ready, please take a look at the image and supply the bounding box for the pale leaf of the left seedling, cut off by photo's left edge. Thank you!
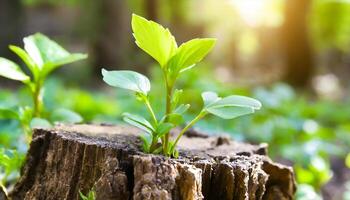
[0,57,30,83]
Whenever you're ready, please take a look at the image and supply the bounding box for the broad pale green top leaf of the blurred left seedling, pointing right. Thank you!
[23,33,87,75]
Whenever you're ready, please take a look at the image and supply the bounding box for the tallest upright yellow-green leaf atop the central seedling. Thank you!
[131,14,177,67]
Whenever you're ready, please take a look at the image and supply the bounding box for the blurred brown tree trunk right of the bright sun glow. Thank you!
[281,0,314,87]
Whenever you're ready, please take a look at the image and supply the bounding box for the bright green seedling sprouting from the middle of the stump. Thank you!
[102,14,261,157]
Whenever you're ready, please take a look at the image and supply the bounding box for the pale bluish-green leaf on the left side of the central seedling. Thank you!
[102,69,151,95]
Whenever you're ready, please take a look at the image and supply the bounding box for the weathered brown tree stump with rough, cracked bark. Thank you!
[9,125,296,200]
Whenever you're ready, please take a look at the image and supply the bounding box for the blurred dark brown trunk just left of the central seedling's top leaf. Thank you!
[93,0,131,74]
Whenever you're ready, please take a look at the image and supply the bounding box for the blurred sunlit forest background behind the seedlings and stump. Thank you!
[0,0,350,200]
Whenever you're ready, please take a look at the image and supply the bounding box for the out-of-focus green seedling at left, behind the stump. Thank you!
[0,33,87,139]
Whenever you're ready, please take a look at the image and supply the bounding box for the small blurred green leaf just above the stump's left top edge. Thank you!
[51,108,83,123]
